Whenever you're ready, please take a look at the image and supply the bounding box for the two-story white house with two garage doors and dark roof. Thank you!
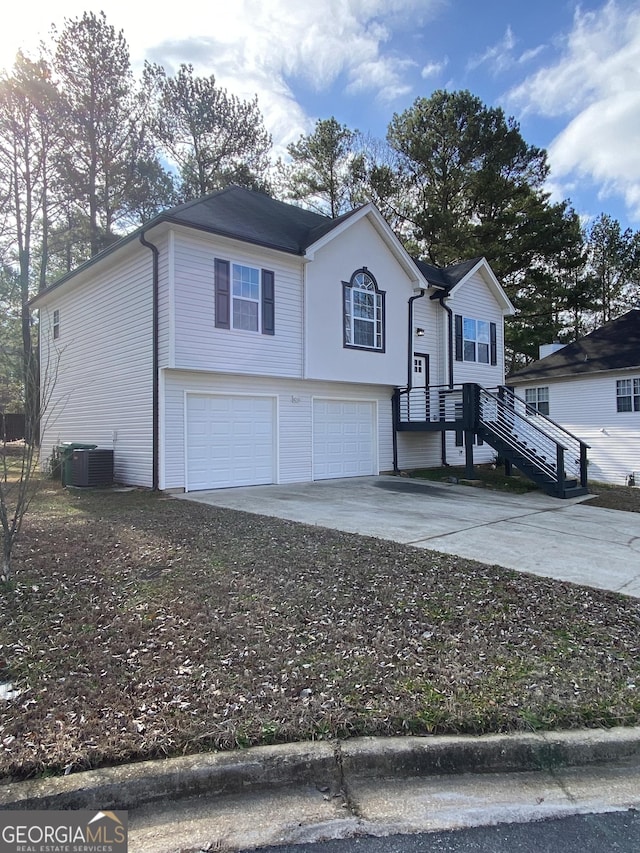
[33,187,513,490]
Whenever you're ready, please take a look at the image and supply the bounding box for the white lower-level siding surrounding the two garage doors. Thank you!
[161,370,393,489]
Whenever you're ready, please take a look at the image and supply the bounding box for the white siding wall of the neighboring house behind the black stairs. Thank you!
[514,372,640,485]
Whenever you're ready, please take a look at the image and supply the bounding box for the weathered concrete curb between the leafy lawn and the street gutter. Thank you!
[0,727,640,810]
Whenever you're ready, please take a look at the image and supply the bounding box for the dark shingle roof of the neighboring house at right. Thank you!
[507,308,640,384]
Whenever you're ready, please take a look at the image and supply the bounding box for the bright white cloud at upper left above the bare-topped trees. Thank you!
[0,0,436,155]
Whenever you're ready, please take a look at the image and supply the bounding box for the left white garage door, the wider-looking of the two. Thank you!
[187,394,275,491]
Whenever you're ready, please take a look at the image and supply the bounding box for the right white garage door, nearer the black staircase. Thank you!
[313,400,378,480]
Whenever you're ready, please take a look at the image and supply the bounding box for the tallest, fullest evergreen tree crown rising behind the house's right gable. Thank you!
[388,91,548,267]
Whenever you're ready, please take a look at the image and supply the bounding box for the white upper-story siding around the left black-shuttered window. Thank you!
[171,231,303,377]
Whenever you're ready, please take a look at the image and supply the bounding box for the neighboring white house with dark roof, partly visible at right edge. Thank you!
[507,308,640,485]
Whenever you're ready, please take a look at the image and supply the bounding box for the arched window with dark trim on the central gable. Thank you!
[342,267,384,352]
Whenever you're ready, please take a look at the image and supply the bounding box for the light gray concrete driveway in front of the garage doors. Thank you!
[179,476,640,598]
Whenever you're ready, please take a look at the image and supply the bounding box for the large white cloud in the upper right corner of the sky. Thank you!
[509,0,640,221]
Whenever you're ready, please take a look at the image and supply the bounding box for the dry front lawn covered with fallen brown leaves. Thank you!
[0,482,640,779]
